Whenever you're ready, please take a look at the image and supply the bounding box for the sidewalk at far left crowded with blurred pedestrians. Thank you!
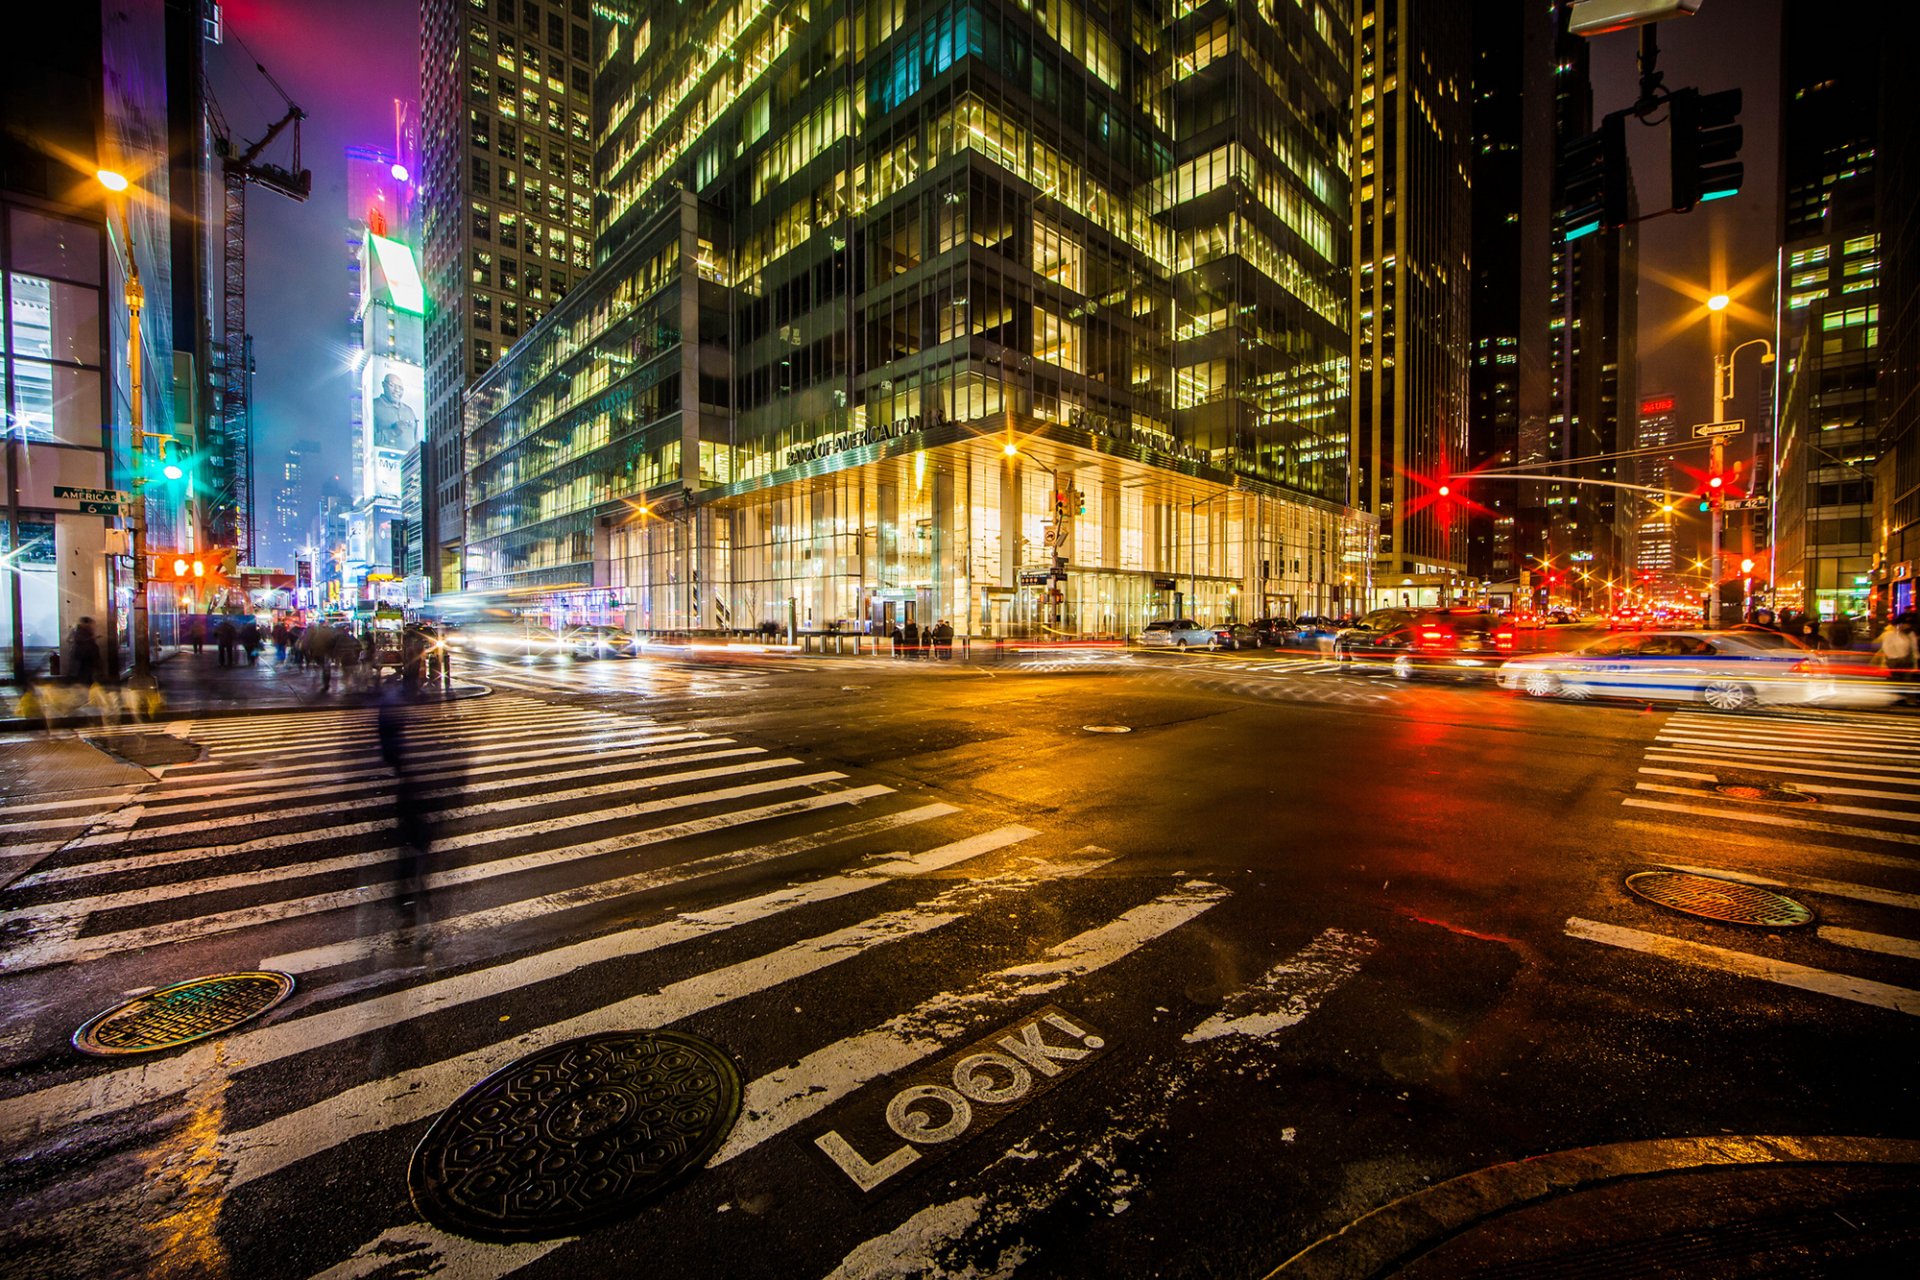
[0,645,488,731]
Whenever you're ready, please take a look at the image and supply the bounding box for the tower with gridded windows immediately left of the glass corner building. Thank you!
[420,0,599,591]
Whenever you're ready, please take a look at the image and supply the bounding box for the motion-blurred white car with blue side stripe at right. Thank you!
[1494,628,1901,712]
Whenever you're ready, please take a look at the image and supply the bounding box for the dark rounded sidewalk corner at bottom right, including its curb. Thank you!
[1269,1136,1920,1280]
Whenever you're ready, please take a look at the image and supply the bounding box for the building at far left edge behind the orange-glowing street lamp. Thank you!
[0,0,186,679]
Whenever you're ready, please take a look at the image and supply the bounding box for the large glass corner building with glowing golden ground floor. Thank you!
[456,0,1371,635]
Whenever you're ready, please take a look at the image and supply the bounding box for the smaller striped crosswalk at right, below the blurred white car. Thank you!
[1567,710,1920,1015]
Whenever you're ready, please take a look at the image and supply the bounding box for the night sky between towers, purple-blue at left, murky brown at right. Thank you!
[232,0,1780,537]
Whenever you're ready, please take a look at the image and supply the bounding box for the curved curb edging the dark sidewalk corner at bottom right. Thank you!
[1269,1134,1920,1280]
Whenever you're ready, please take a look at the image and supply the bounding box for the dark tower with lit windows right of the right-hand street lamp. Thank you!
[1774,0,1882,618]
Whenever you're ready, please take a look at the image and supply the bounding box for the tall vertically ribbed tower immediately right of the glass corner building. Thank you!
[1352,0,1473,604]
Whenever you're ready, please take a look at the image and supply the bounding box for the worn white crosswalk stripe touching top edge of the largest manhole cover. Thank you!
[219,862,1052,1192]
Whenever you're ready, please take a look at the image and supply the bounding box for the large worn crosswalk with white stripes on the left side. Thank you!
[0,694,1375,1276]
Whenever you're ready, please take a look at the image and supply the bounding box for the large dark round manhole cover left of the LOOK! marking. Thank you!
[407,1031,741,1240]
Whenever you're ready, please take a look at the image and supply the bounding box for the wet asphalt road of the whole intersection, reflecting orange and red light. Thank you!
[0,652,1920,1278]
